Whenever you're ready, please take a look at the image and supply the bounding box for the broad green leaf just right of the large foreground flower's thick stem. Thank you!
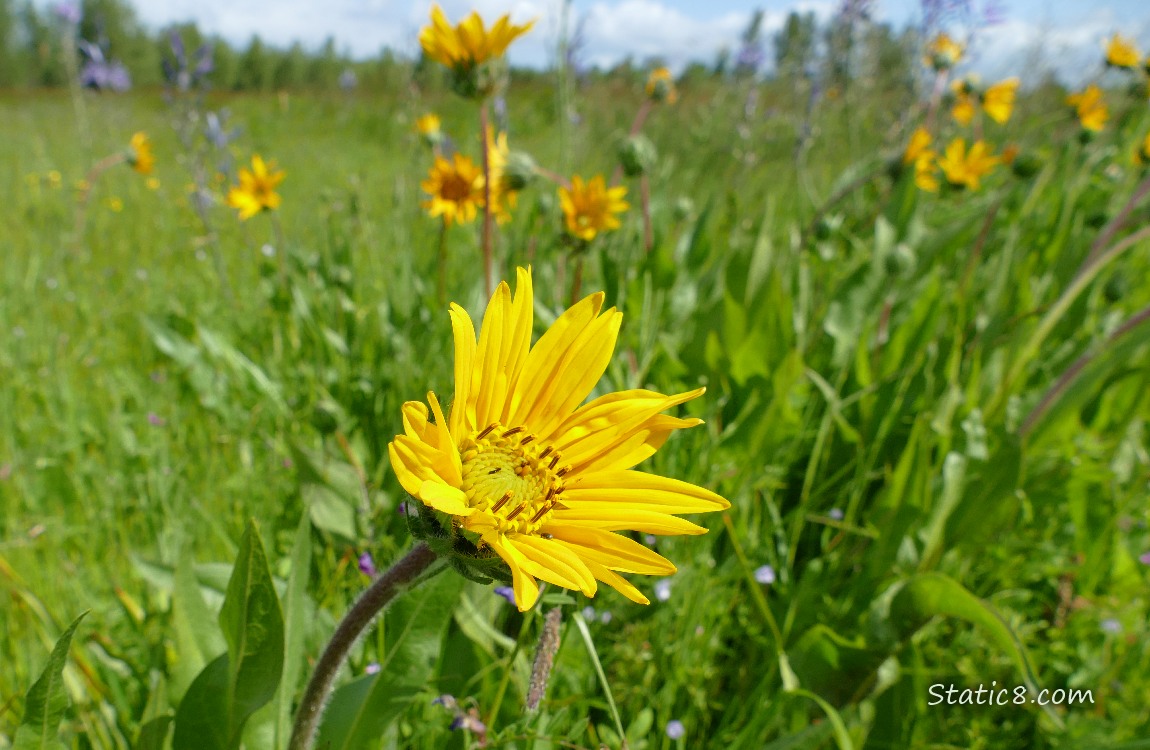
[315,575,463,750]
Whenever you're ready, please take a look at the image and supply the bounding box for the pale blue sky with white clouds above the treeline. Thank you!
[69,0,1150,81]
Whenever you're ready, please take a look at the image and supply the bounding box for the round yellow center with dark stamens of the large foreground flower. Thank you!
[460,422,570,534]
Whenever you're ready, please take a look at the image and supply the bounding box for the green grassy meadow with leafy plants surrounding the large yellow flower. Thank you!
[0,60,1150,750]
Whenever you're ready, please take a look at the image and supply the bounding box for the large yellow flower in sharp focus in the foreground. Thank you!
[388,268,730,612]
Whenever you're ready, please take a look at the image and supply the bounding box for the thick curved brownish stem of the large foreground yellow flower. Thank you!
[288,542,436,750]
